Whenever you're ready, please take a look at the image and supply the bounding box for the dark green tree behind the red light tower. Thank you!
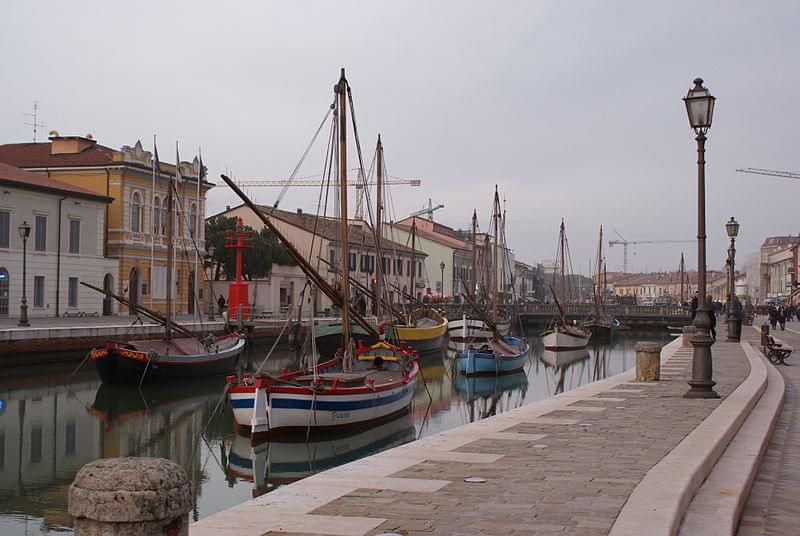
[206,216,296,280]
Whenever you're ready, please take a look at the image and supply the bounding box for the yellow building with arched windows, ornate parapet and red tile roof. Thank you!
[0,131,213,314]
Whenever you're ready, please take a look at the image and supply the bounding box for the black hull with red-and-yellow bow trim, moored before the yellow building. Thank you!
[90,334,245,384]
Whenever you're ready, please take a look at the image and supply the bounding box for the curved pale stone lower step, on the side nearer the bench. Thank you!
[678,342,786,536]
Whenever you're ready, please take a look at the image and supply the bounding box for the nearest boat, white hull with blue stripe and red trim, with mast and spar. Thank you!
[222,69,416,437]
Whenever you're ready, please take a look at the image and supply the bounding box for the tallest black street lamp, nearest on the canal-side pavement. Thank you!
[683,78,719,398]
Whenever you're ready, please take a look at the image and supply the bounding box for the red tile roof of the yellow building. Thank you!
[0,142,116,168]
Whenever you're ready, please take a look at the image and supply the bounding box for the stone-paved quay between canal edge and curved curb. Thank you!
[191,342,756,536]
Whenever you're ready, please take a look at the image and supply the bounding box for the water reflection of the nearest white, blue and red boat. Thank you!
[226,412,416,497]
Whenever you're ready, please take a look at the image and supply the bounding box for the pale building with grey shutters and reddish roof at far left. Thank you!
[0,163,119,318]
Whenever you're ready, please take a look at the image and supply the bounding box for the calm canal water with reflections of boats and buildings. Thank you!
[0,332,670,536]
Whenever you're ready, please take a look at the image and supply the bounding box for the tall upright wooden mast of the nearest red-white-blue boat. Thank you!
[334,68,350,358]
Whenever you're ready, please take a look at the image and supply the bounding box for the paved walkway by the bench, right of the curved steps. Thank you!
[738,317,800,536]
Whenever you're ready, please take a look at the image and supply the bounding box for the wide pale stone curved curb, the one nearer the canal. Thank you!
[609,342,767,536]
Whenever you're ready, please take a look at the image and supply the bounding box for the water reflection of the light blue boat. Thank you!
[454,370,528,422]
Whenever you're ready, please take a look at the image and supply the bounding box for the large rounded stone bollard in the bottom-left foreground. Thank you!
[69,458,192,536]
